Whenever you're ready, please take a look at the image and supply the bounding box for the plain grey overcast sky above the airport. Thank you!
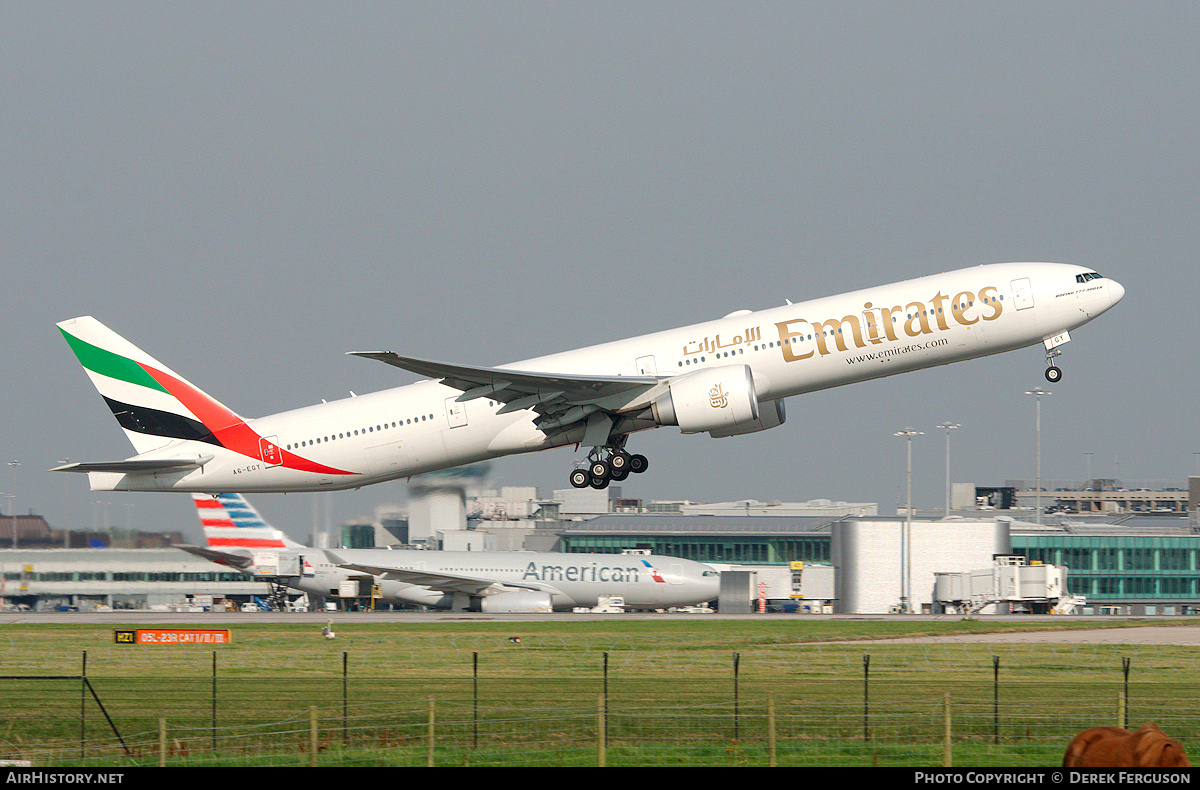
[0,2,1200,539]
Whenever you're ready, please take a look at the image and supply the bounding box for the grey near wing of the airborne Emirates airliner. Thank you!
[348,352,670,438]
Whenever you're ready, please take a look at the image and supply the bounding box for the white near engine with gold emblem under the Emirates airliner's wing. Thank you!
[653,365,763,436]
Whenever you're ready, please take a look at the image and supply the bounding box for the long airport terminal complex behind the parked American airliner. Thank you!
[0,478,1200,616]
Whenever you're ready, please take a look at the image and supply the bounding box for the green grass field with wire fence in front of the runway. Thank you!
[0,617,1200,766]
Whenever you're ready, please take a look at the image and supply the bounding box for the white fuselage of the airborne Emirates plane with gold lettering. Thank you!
[65,263,1123,492]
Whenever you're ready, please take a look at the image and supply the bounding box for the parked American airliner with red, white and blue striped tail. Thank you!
[180,493,720,612]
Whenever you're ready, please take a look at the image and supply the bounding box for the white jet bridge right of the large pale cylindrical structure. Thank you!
[934,555,1085,615]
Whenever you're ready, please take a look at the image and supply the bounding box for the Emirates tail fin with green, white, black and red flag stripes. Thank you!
[58,316,248,454]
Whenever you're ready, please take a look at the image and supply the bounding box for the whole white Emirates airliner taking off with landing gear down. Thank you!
[58,263,1124,493]
